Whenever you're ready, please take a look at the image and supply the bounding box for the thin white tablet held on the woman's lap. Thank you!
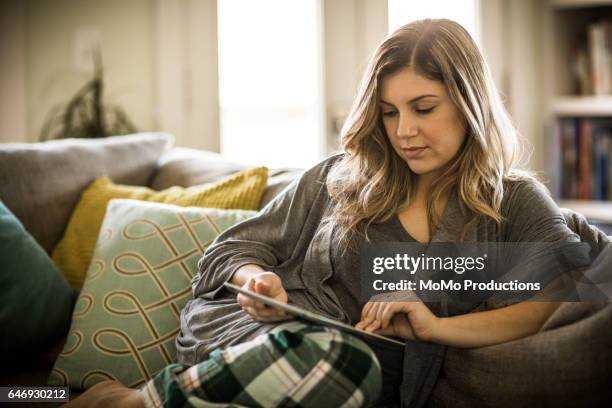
[225,283,406,346]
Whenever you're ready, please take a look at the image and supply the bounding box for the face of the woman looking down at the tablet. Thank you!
[380,68,466,179]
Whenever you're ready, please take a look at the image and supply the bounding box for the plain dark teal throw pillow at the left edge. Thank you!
[0,201,76,361]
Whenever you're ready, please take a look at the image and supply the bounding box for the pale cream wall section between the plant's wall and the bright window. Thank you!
[154,0,220,152]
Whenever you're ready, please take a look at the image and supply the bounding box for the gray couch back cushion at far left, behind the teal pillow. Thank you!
[0,133,173,253]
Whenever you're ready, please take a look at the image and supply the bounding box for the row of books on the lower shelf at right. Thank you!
[551,118,612,200]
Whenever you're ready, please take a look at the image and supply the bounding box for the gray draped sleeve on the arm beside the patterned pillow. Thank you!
[192,156,338,299]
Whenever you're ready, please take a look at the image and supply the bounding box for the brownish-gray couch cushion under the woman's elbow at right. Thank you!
[429,209,612,407]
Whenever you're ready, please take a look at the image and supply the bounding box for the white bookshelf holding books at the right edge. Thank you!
[541,0,612,225]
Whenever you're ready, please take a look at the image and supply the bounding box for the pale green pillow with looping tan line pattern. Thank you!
[49,199,255,389]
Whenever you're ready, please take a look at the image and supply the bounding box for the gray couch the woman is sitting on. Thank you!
[0,133,612,407]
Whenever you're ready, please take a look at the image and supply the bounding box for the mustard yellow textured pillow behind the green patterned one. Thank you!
[53,167,268,288]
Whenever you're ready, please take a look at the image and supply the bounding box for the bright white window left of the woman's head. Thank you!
[218,0,324,167]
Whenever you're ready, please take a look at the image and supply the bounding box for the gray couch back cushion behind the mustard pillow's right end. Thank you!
[150,147,302,208]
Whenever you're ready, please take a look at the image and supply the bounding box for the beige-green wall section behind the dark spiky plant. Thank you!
[23,0,156,141]
